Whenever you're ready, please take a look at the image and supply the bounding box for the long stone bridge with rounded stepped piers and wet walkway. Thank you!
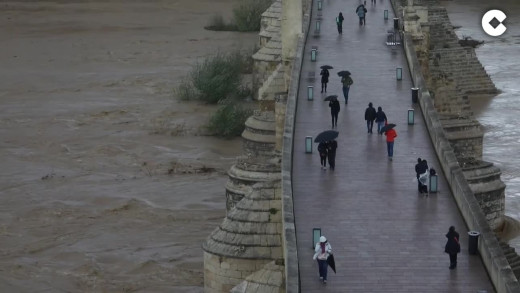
[203,0,520,293]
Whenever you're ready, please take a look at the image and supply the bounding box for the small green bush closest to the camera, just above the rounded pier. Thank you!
[207,103,253,138]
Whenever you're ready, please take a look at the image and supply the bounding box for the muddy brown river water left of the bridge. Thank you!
[0,0,257,292]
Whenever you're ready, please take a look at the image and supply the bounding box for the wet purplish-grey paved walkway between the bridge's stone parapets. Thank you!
[293,0,494,293]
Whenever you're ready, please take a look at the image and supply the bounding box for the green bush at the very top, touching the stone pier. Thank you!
[233,0,273,32]
